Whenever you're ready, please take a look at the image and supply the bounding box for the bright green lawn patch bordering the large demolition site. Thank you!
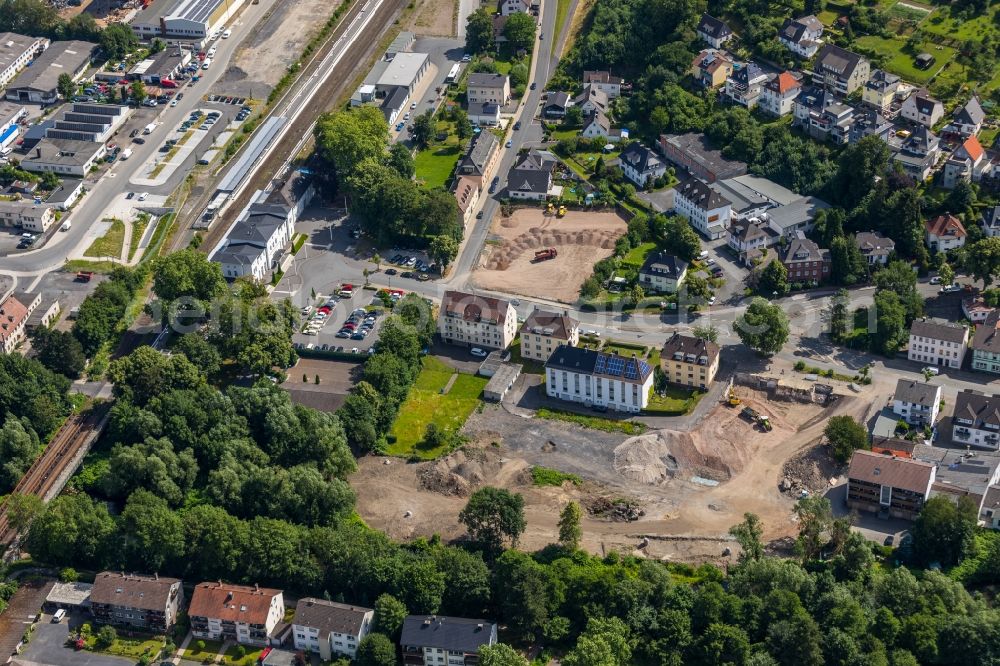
[388,356,487,460]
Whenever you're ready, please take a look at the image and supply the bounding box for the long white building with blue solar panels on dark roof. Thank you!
[545,345,653,413]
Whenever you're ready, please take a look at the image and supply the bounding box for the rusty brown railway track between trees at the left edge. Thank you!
[0,407,107,546]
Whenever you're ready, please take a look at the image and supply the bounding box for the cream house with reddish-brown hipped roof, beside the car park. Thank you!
[438,291,517,349]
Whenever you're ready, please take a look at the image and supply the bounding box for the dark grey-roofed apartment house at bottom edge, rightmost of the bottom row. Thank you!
[399,615,497,666]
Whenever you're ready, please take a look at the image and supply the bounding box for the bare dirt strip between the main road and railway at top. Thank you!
[216,0,340,99]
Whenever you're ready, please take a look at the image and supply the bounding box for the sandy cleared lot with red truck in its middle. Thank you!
[472,208,627,303]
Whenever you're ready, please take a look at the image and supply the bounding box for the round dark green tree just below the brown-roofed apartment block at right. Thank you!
[912,496,978,567]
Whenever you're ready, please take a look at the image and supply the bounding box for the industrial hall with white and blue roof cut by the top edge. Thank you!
[132,0,243,40]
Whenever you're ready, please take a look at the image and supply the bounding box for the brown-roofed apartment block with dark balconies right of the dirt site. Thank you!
[847,450,936,520]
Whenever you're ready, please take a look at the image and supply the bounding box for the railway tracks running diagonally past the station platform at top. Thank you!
[171,0,405,252]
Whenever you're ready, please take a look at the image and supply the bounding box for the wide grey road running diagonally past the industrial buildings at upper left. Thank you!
[0,0,278,278]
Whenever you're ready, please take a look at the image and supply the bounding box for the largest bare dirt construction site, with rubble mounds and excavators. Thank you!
[351,388,869,562]
